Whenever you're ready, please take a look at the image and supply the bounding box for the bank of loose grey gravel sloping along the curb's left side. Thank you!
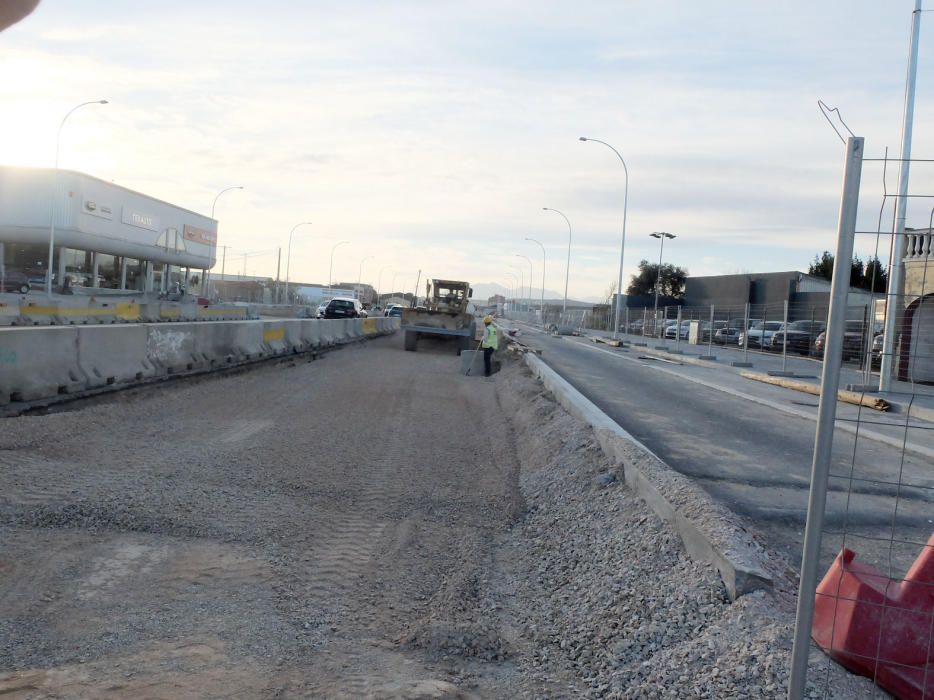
[490,366,887,699]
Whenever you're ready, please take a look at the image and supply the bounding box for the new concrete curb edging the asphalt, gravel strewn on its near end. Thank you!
[525,353,773,600]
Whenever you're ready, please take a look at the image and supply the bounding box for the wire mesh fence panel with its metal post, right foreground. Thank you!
[789,138,934,699]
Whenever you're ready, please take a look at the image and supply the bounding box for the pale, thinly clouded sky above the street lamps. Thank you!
[0,0,934,300]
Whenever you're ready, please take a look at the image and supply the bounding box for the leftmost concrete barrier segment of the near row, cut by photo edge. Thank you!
[0,327,87,404]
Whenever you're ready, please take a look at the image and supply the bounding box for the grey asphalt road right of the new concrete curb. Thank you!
[523,332,934,576]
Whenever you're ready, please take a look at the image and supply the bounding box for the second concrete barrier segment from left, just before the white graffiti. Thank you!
[78,324,156,389]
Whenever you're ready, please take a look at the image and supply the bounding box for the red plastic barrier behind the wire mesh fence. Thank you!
[811,534,934,700]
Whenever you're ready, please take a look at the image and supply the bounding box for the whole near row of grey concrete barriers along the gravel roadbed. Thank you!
[0,314,399,406]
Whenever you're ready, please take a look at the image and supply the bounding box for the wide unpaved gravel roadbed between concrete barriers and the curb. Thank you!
[0,337,884,700]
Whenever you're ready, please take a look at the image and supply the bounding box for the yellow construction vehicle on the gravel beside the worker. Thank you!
[401,280,477,355]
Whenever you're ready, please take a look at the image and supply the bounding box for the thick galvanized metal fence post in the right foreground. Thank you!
[788,136,863,700]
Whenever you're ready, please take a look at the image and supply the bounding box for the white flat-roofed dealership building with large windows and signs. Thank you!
[0,166,217,292]
